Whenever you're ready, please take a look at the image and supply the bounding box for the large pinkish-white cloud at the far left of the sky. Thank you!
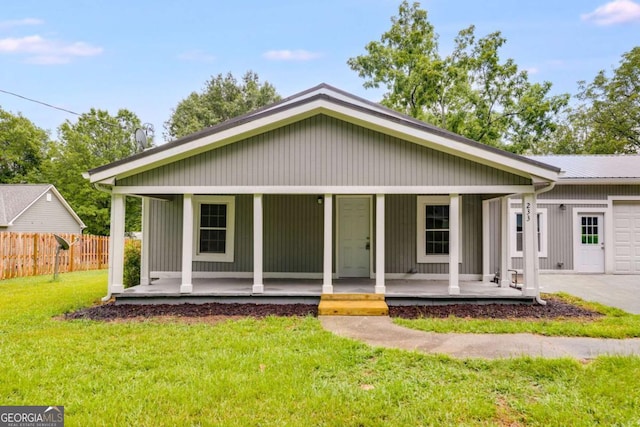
[0,35,103,65]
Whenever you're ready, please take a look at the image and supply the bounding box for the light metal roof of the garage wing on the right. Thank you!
[527,154,640,184]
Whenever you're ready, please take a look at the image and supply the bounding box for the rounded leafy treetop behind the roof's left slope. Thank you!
[164,71,280,138]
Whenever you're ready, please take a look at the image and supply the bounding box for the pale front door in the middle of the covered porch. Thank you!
[337,196,371,277]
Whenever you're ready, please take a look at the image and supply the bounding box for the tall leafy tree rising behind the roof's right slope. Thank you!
[347,0,568,153]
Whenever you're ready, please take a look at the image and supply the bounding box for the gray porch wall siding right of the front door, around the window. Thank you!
[385,194,482,274]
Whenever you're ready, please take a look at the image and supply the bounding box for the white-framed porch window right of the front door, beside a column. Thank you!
[416,196,462,263]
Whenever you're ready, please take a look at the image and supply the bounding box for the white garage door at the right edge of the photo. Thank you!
[613,201,640,274]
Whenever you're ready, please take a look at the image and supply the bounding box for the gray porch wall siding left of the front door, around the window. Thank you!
[150,195,324,273]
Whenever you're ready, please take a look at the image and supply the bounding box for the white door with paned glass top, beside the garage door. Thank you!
[576,213,604,273]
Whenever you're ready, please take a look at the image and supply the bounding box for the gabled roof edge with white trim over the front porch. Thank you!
[87,84,560,184]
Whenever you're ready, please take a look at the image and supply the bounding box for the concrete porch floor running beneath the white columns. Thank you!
[115,278,532,305]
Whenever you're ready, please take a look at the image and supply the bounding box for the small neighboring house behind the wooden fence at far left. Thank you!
[0,184,86,234]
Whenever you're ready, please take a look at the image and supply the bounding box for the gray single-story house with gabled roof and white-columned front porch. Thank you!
[86,84,561,299]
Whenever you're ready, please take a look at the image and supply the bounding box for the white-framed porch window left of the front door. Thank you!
[193,196,235,262]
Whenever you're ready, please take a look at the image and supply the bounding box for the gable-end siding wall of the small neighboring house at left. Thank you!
[9,193,82,233]
